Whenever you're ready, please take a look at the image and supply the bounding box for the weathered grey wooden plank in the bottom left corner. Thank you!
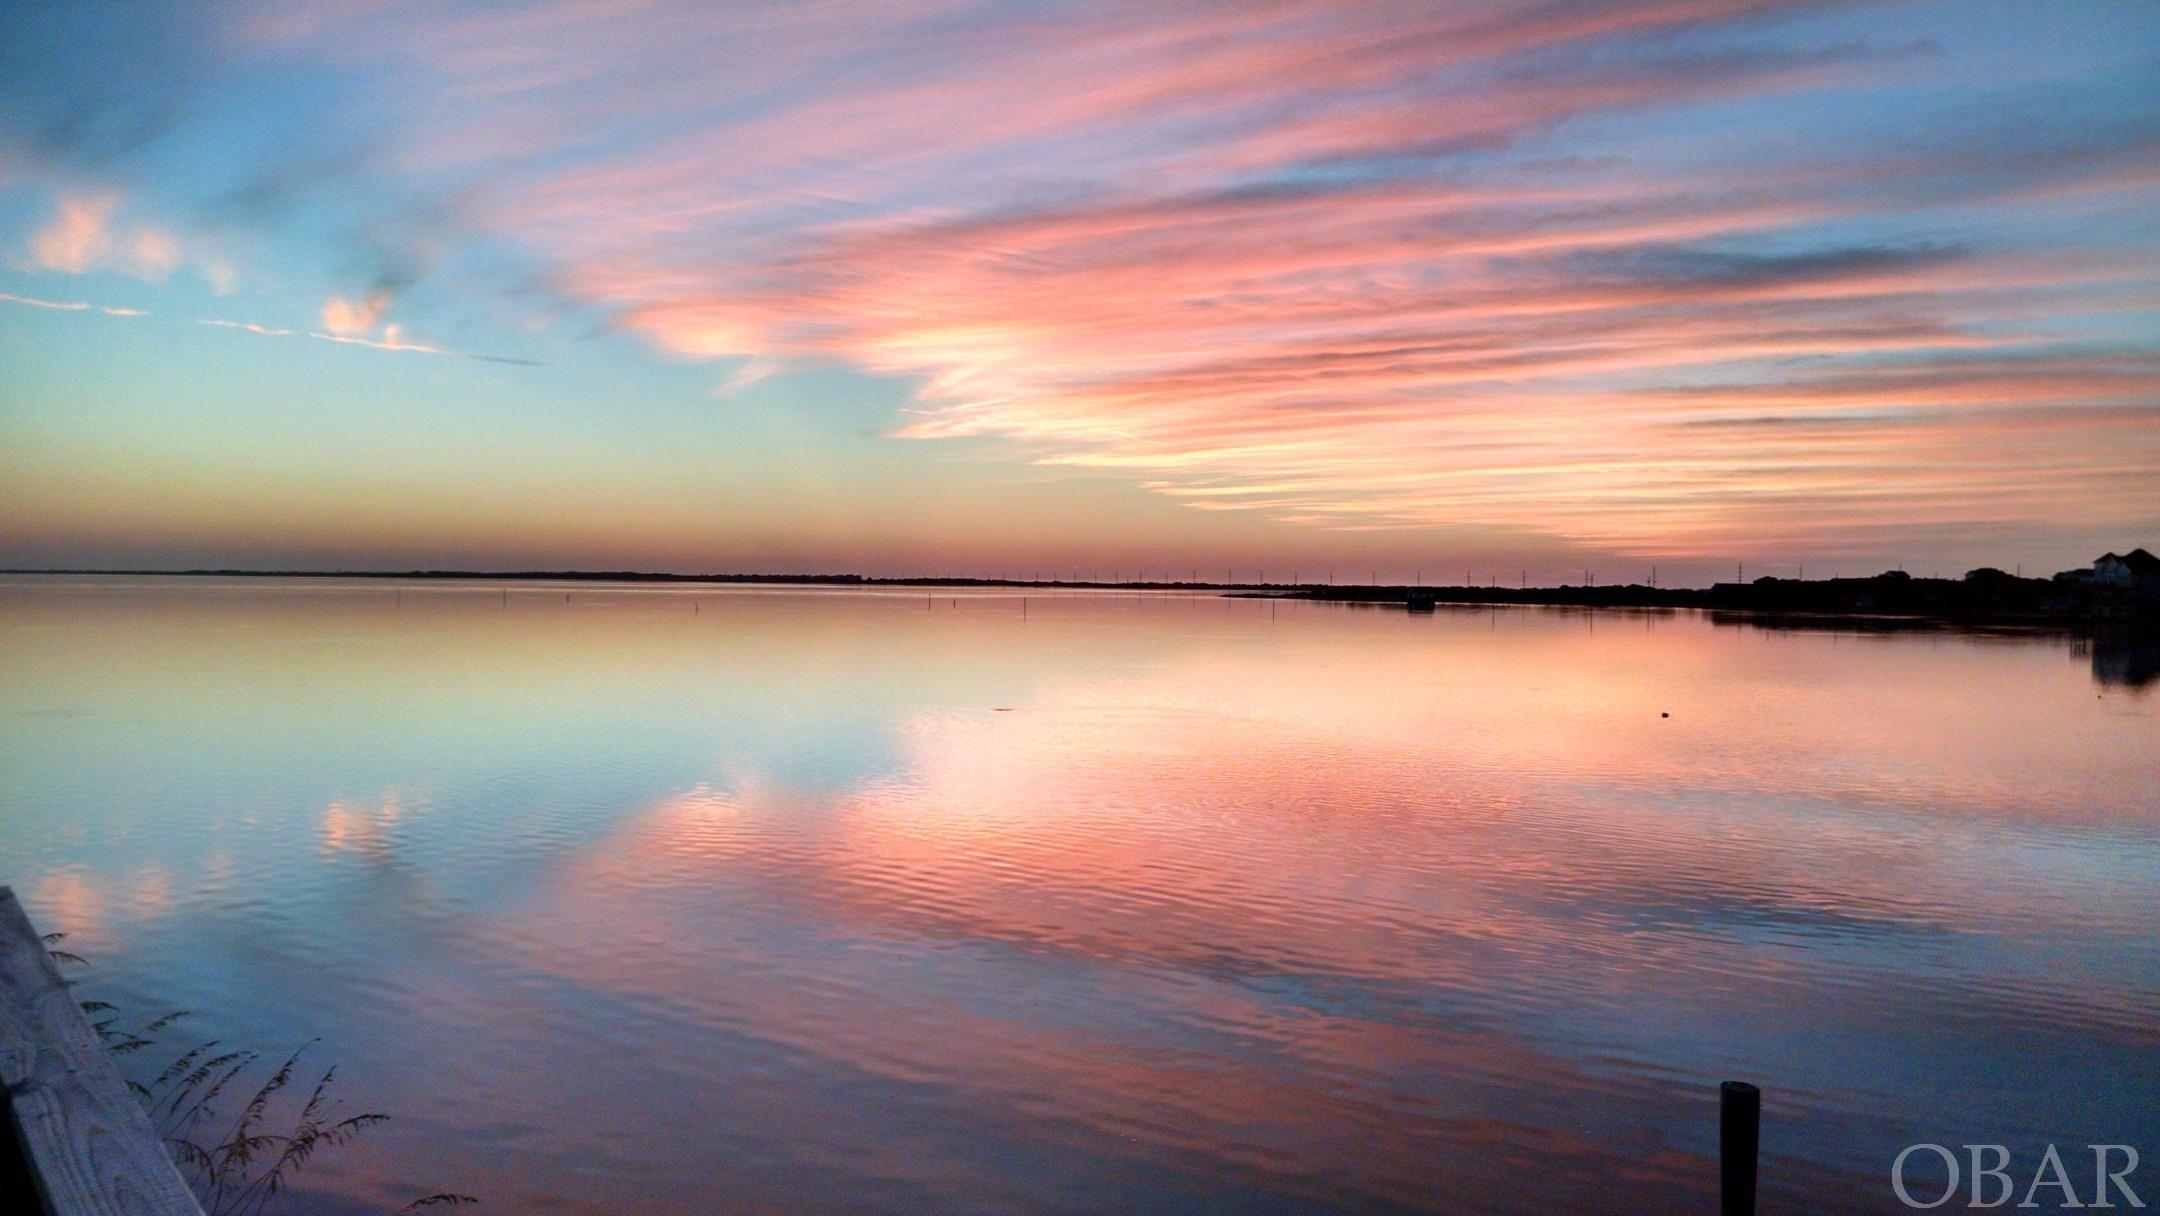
[0,888,203,1216]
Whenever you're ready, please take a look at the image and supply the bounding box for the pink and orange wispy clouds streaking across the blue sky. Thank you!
[4,0,2160,555]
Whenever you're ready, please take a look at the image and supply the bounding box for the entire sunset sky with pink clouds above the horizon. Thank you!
[0,0,2160,583]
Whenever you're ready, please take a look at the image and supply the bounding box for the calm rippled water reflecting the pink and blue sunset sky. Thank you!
[0,579,2160,1216]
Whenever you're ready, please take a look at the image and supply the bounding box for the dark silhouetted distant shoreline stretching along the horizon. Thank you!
[0,568,2160,629]
